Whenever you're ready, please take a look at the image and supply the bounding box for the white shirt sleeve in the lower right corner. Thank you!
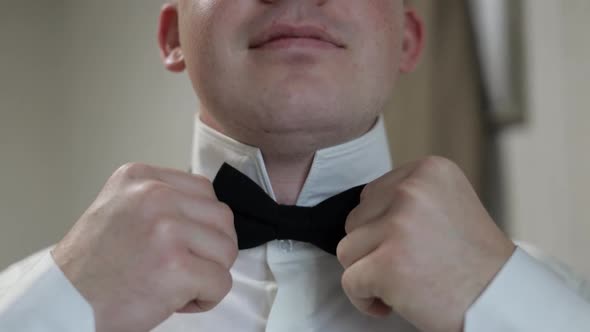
[464,248,590,332]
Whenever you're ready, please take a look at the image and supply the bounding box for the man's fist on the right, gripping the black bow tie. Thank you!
[337,157,515,332]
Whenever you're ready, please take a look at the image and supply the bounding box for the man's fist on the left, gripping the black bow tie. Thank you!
[52,164,238,332]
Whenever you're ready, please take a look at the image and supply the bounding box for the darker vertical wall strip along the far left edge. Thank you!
[0,1,67,270]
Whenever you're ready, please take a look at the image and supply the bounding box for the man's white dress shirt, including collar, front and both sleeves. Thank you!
[0,117,590,332]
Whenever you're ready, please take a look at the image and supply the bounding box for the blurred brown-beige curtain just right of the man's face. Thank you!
[385,0,489,194]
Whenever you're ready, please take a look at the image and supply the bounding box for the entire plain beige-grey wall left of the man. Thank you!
[0,0,197,270]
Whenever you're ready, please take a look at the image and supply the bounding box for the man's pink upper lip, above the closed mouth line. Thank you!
[250,24,345,48]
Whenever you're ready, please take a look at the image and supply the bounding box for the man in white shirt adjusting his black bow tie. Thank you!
[0,0,590,332]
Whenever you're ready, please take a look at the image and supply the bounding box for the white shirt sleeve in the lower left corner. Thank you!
[0,249,95,332]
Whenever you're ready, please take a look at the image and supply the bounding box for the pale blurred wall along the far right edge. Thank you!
[501,0,590,276]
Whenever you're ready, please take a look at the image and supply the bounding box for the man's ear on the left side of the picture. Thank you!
[158,3,186,73]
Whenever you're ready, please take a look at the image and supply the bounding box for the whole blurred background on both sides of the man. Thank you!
[0,0,590,278]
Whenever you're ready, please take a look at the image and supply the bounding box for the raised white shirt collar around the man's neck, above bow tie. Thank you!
[192,115,392,206]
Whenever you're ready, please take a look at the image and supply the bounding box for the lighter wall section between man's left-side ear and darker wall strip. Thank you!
[63,0,197,223]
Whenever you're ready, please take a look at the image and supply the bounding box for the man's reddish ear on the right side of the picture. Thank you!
[400,6,425,73]
